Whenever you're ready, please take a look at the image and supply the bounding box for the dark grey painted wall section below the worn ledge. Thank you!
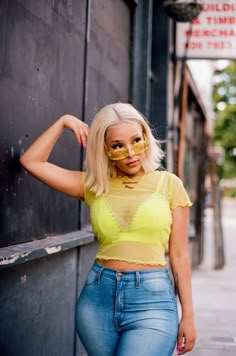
[0,244,96,356]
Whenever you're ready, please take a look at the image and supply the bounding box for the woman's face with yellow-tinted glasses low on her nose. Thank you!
[106,122,146,177]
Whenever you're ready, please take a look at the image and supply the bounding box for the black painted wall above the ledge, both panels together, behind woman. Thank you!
[0,0,131,246]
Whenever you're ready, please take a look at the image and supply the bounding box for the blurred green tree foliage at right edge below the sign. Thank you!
[213,61,236,178]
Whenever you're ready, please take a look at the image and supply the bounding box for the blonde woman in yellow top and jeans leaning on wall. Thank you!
[21,103,196,356]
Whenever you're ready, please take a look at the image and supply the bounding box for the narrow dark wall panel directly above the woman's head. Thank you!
[86,0,131,122]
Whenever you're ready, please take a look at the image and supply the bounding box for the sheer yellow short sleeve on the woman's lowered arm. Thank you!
[168,173,193,209]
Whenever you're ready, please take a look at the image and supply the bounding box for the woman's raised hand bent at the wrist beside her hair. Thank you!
[61,114,89,148]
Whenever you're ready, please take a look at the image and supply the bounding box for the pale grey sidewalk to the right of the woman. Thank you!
[189,199,236,356]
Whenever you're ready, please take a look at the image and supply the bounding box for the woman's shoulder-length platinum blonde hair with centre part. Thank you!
[85,103,164,195]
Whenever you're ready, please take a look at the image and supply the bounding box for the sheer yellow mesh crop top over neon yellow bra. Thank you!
[84,171,192,265]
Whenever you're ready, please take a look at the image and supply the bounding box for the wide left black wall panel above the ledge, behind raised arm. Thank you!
[0,0,86,246]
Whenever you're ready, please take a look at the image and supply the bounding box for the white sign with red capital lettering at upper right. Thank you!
[176,0,236,59]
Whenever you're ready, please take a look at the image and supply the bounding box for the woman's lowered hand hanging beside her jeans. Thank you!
[177,318,196,355]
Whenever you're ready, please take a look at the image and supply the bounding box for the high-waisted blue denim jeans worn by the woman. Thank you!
[76,262,178,356]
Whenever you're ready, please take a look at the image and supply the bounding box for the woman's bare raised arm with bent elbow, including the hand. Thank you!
[20,115,89,200]
